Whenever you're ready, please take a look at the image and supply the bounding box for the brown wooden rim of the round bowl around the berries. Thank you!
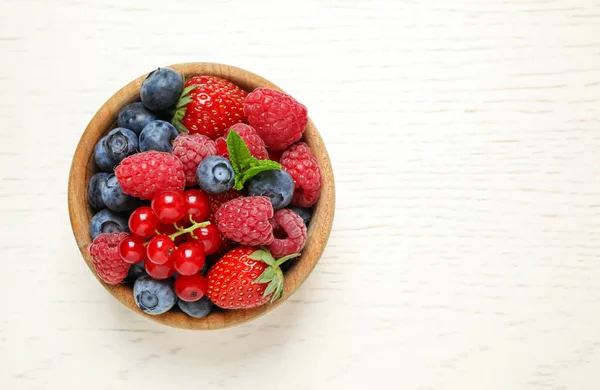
[68,63,335,329]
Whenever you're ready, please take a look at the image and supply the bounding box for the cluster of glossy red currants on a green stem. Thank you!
[119,190,221,302]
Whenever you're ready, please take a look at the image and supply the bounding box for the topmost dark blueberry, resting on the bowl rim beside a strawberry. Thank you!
[140,68,183,111]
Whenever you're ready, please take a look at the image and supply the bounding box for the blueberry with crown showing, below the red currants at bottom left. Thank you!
[133,276,177,315]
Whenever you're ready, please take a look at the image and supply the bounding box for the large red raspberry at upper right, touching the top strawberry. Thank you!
[244,88,308,150]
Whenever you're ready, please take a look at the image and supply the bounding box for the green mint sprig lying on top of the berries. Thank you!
[227,130,281,191]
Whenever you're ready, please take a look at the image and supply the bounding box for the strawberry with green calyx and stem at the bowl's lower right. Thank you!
[206,246,300,309]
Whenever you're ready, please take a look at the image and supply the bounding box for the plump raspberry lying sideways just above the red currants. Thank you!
[115,151,185,199]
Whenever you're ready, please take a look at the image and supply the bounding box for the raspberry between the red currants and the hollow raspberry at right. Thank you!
[216,196,274,246]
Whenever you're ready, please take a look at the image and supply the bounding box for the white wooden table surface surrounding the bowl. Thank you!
[0,0,600,390]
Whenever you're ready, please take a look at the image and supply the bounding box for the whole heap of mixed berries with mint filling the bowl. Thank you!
[87,68,321,318]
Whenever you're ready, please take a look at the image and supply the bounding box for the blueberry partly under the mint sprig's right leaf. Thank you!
[248,169,294,210]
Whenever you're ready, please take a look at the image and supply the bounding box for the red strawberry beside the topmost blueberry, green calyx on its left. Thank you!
[173,76,248,139]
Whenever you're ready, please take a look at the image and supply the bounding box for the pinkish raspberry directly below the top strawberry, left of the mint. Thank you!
[173,134,217,187]
